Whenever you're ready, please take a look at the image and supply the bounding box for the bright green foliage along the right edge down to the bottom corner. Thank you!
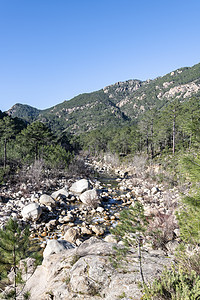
[143,132,200,300]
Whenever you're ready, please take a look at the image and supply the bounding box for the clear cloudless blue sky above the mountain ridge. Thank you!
[0,0,200,111]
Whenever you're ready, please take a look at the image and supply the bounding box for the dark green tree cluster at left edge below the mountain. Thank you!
[0,114,76,184]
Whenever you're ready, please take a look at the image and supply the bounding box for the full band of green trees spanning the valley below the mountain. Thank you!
[0,97,200,181]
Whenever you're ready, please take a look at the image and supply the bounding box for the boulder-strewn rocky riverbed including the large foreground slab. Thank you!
[0,158,179,300]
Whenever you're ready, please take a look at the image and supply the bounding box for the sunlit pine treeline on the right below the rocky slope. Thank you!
[80,98,200,158]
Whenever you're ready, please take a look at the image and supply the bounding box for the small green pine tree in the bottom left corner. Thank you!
[0,219,30,299]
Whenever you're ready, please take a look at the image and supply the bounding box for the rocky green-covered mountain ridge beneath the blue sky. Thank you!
[8,64,200,133]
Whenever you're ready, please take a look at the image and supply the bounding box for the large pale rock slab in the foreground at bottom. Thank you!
[25,237,172,300]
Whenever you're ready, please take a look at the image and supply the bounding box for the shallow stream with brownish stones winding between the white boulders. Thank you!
[34,174,131,247]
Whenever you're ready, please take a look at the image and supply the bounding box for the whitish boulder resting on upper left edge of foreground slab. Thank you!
[43,240,74,258]
